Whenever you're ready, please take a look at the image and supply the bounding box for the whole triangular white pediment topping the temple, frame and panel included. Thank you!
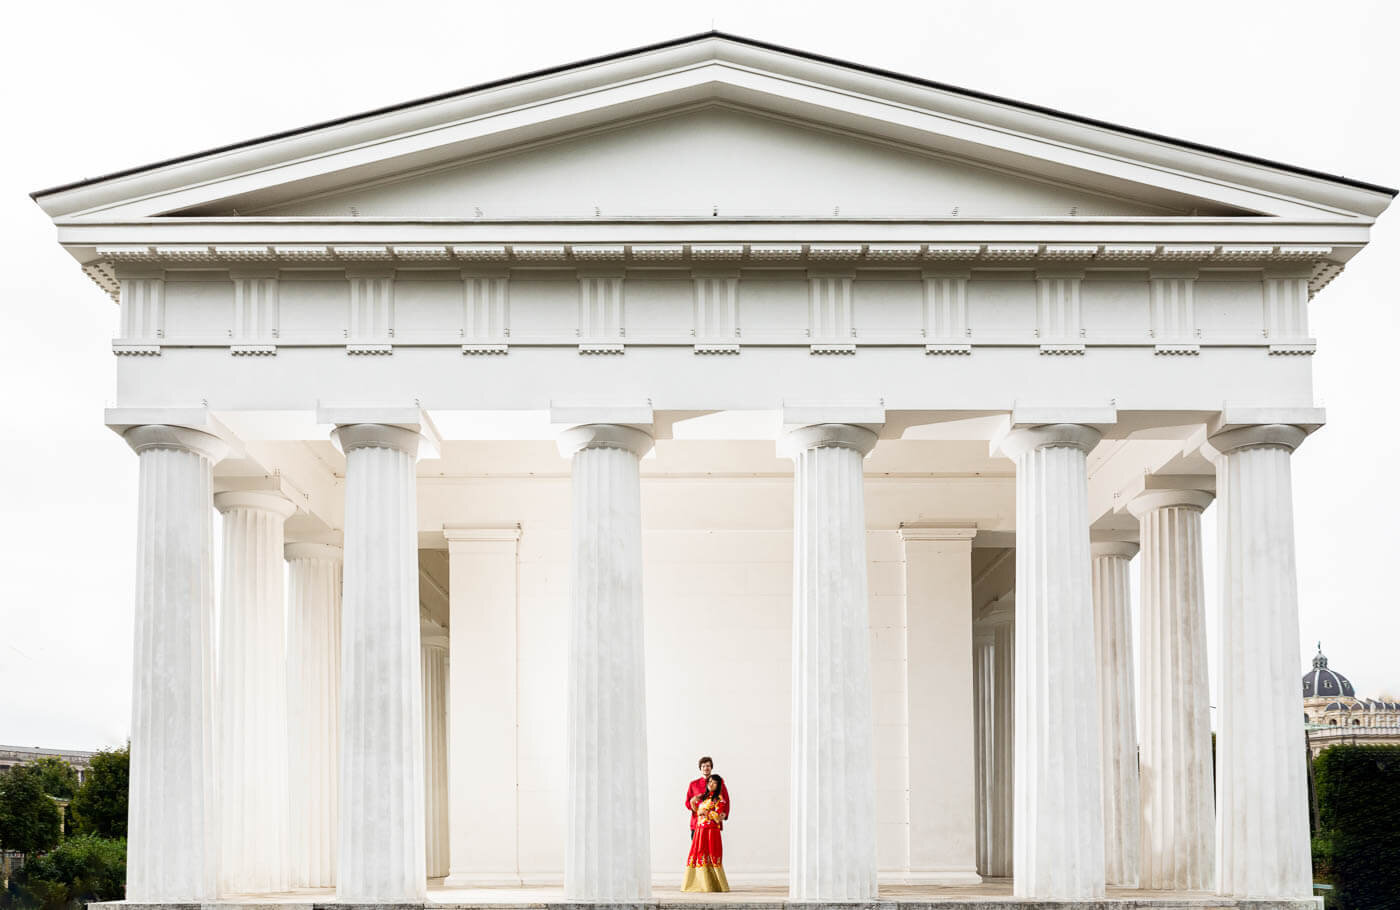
[35,34,1392,221]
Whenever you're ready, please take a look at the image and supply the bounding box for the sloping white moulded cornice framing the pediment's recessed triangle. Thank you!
[27,34,1392,221]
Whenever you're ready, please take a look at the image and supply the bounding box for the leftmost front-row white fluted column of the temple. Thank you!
[123,426,228,903]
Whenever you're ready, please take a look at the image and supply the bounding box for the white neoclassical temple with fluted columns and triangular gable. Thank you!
[35,32,1394,907]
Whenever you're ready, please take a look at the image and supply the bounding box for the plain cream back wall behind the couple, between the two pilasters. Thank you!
[449,512,909,885]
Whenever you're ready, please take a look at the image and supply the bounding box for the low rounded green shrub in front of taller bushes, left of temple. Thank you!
[6,834,126,910]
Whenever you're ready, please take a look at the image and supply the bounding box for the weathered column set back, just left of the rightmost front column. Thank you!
[1128,490,1215,890]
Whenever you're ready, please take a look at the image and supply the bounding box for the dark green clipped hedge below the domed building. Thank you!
[1313,746,1400,910]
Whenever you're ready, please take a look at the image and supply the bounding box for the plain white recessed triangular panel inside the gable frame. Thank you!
[204,105,1215,220]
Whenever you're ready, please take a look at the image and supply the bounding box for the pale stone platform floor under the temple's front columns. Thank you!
[88,876,1322,910]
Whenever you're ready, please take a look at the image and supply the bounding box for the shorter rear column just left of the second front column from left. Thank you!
[283,542,344,888]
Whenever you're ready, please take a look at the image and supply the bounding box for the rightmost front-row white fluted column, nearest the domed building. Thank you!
[1208,424,1312,897]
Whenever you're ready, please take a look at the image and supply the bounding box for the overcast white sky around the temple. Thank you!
[0,0,1400,749]
